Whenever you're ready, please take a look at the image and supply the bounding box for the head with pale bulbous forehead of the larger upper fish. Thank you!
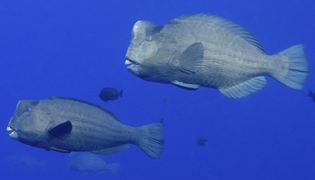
[125,21,169,81]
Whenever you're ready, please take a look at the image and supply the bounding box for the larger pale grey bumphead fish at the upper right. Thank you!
[125,13,310,99]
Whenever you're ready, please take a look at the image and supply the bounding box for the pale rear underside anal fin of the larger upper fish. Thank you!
[218,76,268,99]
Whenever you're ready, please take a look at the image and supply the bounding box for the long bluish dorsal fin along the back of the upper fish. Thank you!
[170,13,265,53]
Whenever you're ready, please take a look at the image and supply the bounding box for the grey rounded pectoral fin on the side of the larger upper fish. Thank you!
[179,42,204,74]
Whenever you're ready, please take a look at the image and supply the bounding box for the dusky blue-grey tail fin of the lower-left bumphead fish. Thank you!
[137,123,164,159]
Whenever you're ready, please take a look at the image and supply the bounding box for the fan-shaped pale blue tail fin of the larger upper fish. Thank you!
[274,45,310,90]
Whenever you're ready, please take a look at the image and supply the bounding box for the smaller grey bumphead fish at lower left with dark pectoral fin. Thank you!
[7,97,164,159]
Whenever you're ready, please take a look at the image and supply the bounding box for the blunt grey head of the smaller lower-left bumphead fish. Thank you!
[7,100,50,146]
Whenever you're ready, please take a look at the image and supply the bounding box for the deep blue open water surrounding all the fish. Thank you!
[0,0,315,180]
